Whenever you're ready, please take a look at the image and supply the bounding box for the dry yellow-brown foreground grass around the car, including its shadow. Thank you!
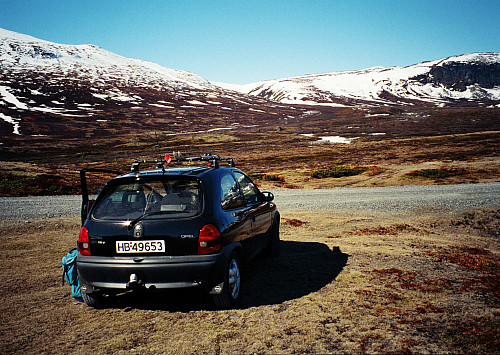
[0,210,500,354]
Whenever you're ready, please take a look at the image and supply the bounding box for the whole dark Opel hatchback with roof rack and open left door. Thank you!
[77,155,280,308]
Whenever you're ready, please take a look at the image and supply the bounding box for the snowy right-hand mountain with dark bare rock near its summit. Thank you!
[223,53,500,106]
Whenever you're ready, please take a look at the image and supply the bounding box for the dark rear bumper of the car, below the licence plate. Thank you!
[77,253,226,293]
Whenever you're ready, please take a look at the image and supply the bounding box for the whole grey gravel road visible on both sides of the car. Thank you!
[0,183,500,220]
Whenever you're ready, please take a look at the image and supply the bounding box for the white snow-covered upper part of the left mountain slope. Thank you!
[0,29,210,88]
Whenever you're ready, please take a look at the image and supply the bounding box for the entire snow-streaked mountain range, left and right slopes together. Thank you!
[0,29,500,138]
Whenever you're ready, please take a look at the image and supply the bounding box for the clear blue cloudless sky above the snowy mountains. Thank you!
[0,0,500,84]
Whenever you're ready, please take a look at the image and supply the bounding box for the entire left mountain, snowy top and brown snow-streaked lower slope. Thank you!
[0,29,304,137]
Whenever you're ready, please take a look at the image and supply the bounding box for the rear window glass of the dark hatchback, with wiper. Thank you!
[92,176,202,220]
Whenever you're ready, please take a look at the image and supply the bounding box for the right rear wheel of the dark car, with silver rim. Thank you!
[212,253,241,309]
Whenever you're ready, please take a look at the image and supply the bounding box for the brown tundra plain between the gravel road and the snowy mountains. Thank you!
[0,107,500,196]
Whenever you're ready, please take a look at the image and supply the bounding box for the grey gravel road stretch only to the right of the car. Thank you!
[275,183,500,215]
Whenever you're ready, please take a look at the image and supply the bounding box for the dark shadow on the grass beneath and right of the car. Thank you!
[107,241,348,312]
